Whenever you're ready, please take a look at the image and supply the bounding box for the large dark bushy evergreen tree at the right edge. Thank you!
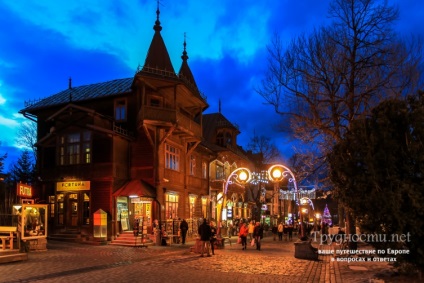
[329,93,424,270]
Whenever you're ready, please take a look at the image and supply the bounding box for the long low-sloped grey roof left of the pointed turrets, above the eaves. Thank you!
[19,78,134,113]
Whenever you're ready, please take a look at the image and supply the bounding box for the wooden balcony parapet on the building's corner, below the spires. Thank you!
[138,106,202,137]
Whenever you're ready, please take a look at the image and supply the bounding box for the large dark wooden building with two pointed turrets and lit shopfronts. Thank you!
[20,7,216,240]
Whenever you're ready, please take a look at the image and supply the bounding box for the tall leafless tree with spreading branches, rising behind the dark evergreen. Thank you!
[256,0,422,244]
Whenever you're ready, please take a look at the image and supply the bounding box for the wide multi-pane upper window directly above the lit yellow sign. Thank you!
[59,131,91,165]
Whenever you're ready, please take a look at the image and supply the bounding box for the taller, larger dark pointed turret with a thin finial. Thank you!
[142,3,175,76]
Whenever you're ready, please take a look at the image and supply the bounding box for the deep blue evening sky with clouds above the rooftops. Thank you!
[0,0,424,171]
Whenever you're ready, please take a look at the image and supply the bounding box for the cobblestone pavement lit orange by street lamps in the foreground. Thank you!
[0,237,400,283]
